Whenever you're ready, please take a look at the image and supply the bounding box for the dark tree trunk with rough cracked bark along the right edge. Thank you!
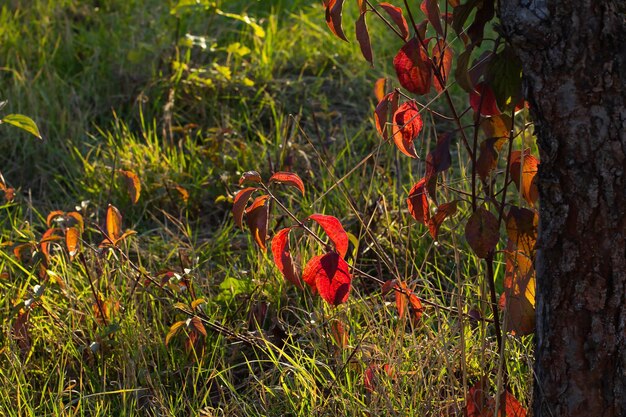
[499,0,626,417]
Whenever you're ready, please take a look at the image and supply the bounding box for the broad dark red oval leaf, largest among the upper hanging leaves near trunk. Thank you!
[393,38,432,95]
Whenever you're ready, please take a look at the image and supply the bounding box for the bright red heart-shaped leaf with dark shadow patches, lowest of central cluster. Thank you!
[302,252,352,306]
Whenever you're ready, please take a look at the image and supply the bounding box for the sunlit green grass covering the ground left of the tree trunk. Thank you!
[0,0,532,416]
